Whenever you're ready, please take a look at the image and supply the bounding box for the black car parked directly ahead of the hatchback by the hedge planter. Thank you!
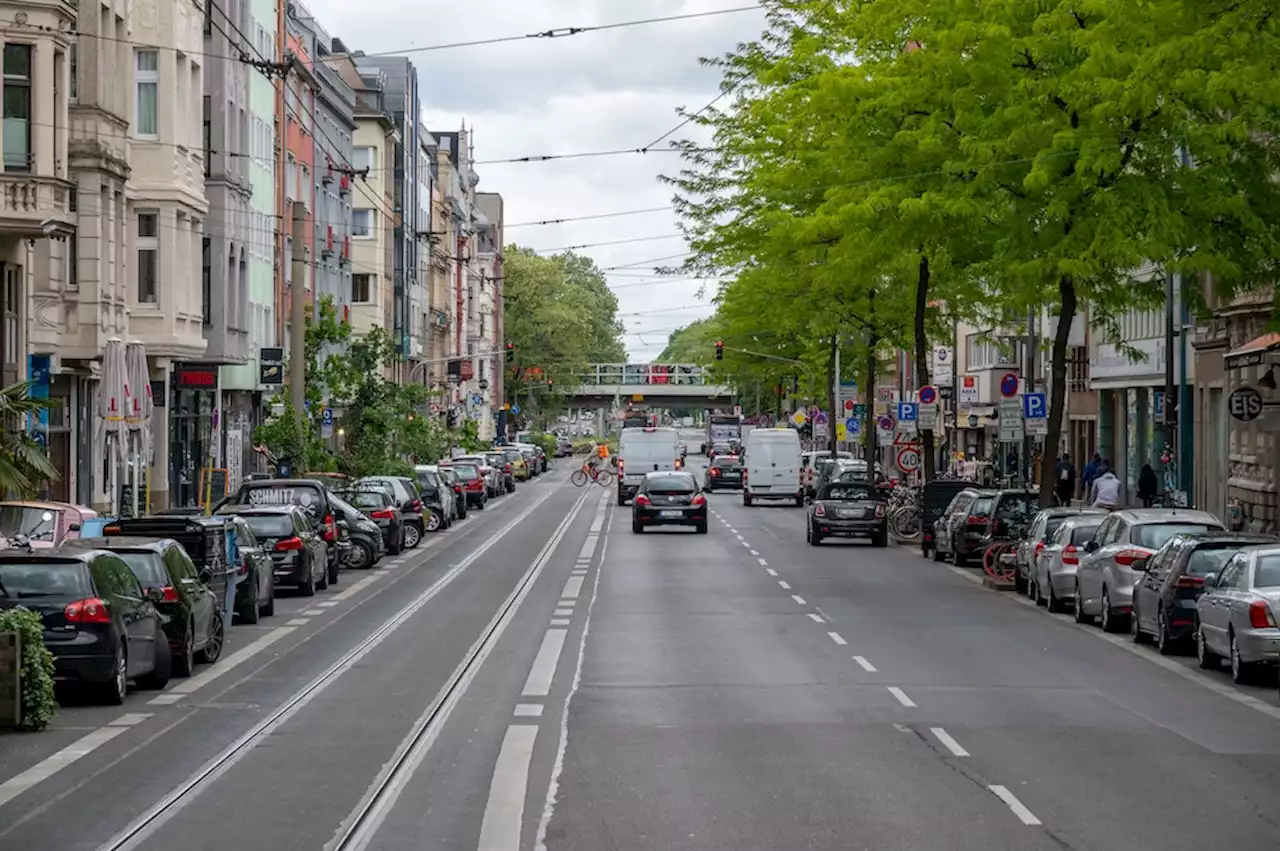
[59,537,225,677]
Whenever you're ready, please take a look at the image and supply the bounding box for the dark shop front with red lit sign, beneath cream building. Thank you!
[169,363,220,508]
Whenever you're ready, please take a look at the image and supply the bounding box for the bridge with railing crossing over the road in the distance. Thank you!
[563,363,733,408]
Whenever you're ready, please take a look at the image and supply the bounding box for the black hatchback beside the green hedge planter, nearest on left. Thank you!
[0,549,173,705]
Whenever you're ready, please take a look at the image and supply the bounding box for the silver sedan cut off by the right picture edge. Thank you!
[1196,544,1280,685]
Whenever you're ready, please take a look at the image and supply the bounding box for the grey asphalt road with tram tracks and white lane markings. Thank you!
[0,457,1280,851]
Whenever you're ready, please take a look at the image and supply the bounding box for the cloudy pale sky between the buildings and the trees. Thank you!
[306,0,764,361]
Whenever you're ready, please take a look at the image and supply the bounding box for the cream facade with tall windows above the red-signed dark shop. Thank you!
[128,4,208,508]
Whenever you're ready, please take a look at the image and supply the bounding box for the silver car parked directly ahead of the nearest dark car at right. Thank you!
[1074,508,1226,632]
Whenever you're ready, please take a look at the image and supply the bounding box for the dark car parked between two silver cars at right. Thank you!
[1129,532,1275,655]
